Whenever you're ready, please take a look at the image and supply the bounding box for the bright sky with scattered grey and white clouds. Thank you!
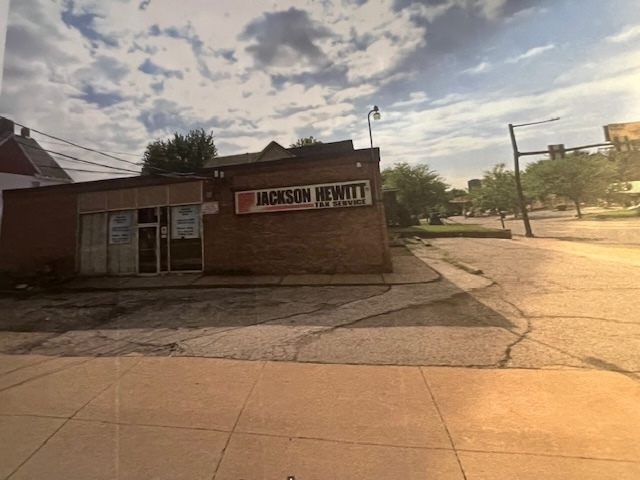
[0,0,640,187]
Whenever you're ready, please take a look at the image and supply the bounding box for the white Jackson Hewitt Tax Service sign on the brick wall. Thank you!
[236,180,373,214]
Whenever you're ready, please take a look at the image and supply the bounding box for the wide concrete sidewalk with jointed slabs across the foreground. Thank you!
[0,356,640,480]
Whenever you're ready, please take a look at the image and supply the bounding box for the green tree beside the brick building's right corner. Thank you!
[382,163,448,216]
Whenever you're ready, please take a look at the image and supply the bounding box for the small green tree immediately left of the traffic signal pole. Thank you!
[470,163,520,212]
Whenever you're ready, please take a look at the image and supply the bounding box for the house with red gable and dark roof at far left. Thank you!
[0,117,73,234]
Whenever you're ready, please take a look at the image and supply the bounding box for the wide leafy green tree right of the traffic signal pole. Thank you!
[524,152,616,218]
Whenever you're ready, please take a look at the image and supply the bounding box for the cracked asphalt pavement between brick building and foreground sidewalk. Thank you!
[0,231,640,376]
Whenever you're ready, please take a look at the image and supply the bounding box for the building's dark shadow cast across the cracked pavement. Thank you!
[0,280,516,355]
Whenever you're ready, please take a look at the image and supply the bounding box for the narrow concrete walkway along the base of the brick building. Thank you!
[61,247,440,291]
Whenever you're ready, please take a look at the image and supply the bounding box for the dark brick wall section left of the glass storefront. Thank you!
[0,188,77,276]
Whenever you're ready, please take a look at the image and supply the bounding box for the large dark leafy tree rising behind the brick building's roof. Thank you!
[141,129,218,175]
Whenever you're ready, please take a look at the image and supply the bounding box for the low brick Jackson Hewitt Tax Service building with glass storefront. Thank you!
[0,141,391,276]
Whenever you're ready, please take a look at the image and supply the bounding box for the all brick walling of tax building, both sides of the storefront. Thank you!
[0,150,391,275]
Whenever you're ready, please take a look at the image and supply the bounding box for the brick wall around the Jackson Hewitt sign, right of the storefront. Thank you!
[203,151,391,274]
